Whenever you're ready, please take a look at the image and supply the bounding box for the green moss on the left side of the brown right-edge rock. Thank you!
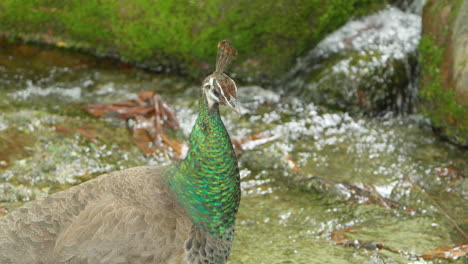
[419,0,468,145]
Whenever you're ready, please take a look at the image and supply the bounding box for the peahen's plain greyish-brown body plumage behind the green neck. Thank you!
[0,167,193,264]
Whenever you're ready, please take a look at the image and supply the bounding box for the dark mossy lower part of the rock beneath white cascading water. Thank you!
[300,50,416,114]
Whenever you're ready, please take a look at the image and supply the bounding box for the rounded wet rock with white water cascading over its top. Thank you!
[286,7,420,113]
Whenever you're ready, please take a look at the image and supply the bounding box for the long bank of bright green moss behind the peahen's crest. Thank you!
[0,0,388,81]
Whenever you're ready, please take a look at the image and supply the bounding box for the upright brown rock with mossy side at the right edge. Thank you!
[419,0,468,146]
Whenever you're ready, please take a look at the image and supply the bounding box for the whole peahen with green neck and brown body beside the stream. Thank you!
[0,41,241,264]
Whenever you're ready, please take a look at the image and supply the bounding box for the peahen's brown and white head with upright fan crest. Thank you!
[202,40,239,113]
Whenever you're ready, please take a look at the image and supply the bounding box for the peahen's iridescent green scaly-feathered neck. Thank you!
[170,92,240,239]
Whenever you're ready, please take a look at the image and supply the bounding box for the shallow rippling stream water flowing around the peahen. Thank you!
[0,40,468,264]
